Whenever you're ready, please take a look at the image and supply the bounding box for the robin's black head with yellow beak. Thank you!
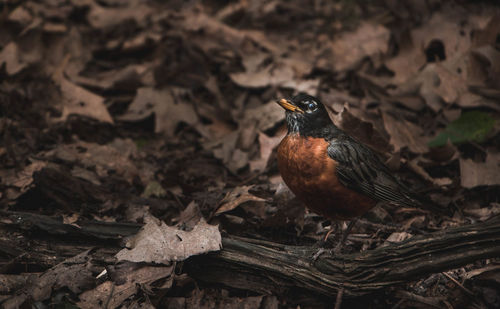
[277,94,333,136]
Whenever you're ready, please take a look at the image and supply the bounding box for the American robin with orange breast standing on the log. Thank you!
[277,94,448,225]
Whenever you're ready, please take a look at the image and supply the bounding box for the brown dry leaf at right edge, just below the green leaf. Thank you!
[460,153,500,189]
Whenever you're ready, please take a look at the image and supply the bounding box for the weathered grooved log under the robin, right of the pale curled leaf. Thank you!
[186,216,500,297]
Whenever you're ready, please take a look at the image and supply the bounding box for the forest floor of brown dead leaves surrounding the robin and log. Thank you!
[0,0,500,309]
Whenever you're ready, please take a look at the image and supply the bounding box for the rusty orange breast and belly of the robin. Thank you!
[278,134,376,220]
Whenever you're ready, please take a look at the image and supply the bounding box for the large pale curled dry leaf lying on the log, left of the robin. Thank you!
[116,217,222,264]
